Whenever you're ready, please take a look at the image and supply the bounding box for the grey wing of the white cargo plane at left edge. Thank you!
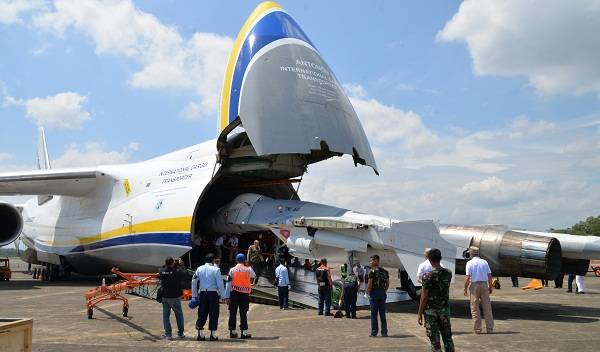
[0,169,104,196]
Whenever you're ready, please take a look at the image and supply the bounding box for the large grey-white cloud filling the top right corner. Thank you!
[437,0,600,94]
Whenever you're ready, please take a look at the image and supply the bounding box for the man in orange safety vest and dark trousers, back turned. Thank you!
[225,253,256,339]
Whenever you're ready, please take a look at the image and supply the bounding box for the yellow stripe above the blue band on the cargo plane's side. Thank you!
[43,216,192,246]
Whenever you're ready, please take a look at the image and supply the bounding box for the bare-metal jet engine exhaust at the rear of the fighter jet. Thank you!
[440,225,561,279]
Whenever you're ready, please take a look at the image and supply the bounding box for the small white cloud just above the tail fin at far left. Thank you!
[4,92,91,129]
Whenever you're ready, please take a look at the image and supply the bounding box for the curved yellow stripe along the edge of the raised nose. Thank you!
[219,1,282,133]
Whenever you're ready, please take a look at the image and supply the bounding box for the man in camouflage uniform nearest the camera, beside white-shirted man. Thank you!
[418,248,454,352]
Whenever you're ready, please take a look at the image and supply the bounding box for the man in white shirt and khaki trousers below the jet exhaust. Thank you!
[465,247,494,334]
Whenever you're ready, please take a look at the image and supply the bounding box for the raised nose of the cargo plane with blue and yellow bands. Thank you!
[218,2,377,172]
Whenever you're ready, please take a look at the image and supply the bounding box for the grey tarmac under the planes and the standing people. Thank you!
[0,261,600,352]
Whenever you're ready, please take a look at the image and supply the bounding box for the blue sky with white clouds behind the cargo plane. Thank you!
[0,0,600,230]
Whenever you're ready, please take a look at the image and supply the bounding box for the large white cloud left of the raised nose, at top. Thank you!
[34,0,233,118]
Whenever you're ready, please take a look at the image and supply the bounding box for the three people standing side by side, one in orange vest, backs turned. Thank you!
[159,253,256,341]
